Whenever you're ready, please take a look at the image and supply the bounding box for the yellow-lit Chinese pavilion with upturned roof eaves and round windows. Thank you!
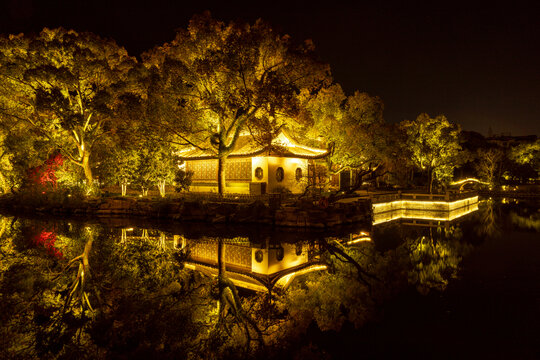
[179,131,328,194]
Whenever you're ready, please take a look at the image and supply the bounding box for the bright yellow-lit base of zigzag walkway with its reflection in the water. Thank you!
[373,196,478,225]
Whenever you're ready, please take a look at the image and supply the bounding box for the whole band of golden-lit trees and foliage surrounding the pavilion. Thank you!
[0,13,538,196]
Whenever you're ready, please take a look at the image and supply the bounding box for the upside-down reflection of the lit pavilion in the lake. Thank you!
[179,236,326,291]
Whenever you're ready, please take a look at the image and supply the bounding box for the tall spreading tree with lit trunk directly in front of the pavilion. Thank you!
[143,13,330,194]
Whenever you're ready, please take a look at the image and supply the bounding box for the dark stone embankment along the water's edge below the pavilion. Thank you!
[0,198,372,228]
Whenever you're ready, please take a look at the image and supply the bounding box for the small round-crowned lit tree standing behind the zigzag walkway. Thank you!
[401,113,461,193]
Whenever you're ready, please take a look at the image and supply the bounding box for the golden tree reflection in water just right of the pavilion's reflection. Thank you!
[281,239,384,334]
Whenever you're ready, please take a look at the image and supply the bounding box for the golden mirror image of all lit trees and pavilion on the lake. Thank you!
[0,198,538,358]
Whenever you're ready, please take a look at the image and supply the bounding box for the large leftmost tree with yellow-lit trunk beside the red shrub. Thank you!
[0,28,135,185]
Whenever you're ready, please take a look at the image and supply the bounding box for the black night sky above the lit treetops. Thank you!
[0,0,540,135]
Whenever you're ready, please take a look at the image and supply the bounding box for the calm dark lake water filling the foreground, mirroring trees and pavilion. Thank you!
[0,199,540,359]
